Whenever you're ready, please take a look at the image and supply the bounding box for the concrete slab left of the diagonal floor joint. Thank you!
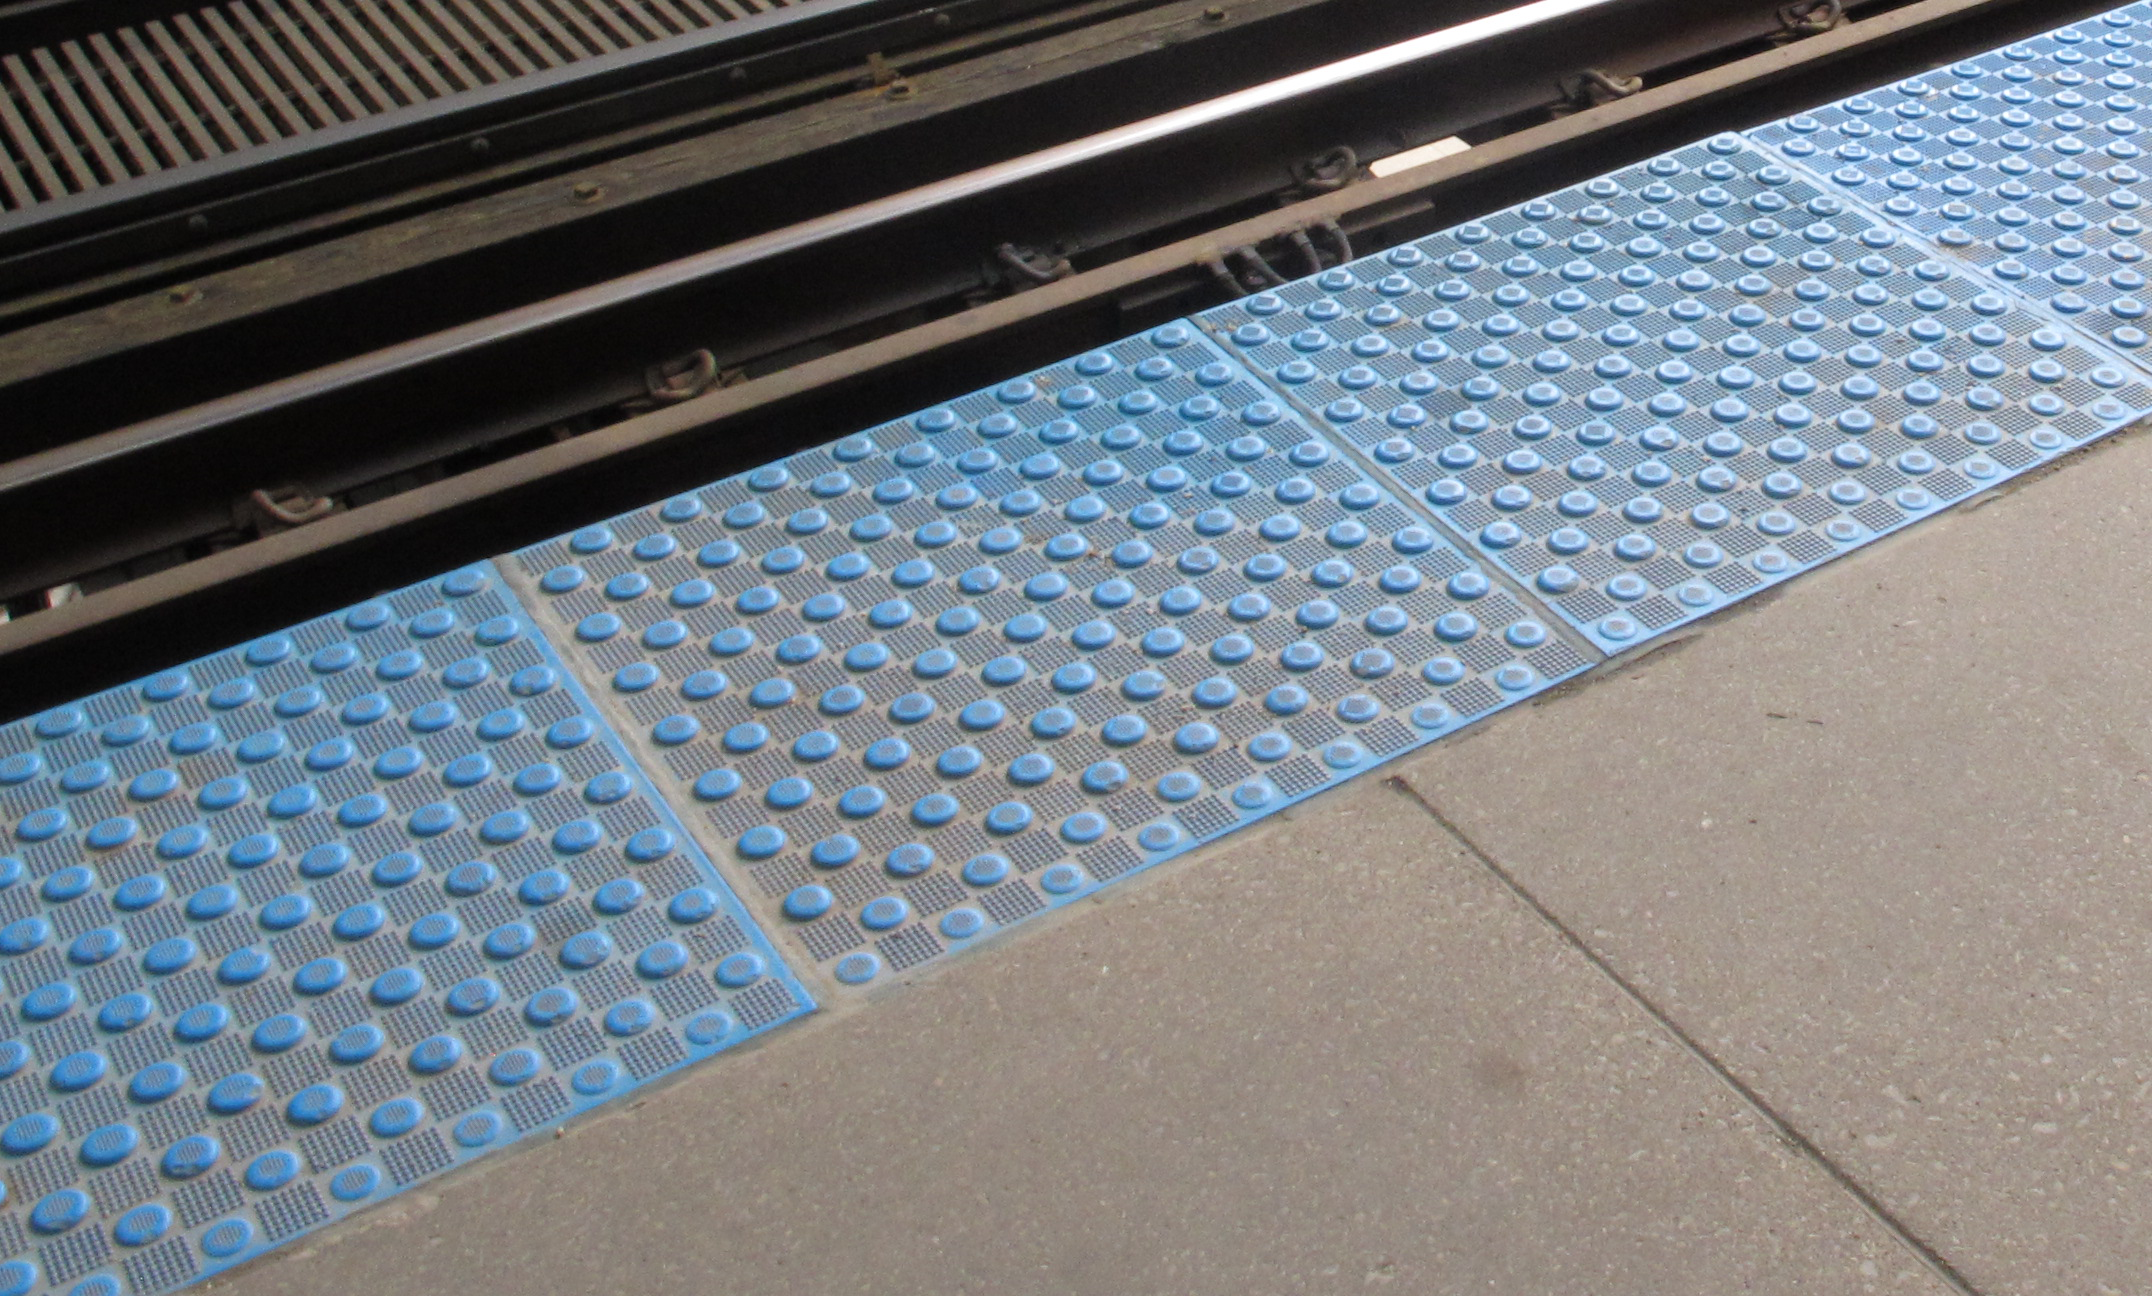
[217,779,1943,1296]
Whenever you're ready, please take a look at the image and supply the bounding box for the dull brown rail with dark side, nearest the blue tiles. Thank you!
[0,0,2107,717]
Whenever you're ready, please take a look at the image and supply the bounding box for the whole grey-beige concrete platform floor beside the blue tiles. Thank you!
[189,433,2152,1296]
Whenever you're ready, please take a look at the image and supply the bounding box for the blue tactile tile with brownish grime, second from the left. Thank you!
[504,323,1586,984]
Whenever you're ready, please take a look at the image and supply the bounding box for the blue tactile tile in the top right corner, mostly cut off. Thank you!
[1750,4,2152,353]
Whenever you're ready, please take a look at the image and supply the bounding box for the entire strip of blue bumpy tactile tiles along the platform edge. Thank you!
[12,4,2152,1296]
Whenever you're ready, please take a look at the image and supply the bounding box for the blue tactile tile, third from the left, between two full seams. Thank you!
[1199,136,2152,650]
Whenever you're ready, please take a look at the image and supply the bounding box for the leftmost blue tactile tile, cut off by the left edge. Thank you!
[0,566,811,1294]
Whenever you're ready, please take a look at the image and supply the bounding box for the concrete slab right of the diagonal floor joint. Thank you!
[1403,435,2152,1294]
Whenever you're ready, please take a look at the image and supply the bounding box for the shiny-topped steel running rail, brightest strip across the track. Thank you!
[0,0,1633,495]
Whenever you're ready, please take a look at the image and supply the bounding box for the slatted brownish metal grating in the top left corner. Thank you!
[0,0,790,213]
